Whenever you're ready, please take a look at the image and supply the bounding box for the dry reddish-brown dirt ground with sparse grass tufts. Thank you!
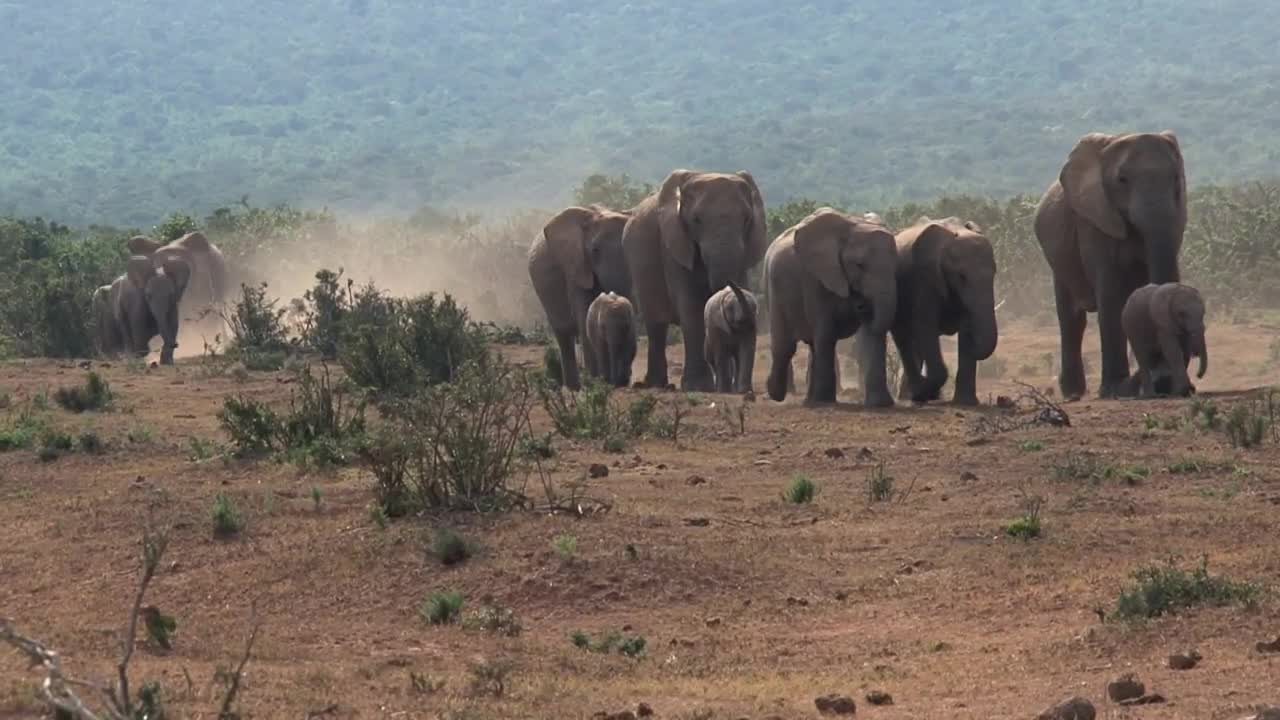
[0,319,1280,720]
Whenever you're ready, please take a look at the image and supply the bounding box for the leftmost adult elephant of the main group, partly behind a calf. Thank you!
[529,205,631,389]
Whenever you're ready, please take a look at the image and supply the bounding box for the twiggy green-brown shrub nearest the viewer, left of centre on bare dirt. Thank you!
[360,356,534,518]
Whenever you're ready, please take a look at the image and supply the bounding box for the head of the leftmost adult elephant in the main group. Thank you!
[543,205,631,297]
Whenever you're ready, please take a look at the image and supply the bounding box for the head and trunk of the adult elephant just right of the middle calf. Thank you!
[795,208,897,334]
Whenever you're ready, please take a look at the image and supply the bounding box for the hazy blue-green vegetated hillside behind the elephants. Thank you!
[0,0,1280,224]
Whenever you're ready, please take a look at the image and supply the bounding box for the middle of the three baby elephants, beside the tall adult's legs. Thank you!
[703,282,755,392]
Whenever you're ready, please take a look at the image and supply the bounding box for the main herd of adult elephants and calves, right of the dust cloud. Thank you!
[529,131,1208,407]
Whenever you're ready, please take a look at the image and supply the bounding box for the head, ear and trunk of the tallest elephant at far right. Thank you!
[1059,131,1187,284]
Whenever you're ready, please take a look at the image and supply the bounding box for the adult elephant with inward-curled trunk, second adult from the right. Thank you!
[892,218,1000,405]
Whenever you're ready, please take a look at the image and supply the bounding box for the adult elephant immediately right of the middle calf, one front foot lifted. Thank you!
[764,208,897,407]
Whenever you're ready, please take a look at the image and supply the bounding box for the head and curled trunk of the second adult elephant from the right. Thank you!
[916,218,1000,360]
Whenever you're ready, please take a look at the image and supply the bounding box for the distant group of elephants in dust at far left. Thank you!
[93,232,227,365]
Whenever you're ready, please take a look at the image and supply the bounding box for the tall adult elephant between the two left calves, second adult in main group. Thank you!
[622,169,765,392]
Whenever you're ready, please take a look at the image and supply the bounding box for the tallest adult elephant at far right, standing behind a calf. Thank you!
[1036,131,1187,400]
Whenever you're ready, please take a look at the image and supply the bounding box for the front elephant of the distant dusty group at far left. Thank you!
[104,255,191,365]
